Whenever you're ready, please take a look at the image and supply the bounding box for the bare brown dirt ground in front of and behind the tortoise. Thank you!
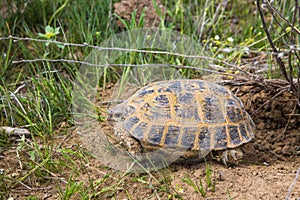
[0,81,300,200]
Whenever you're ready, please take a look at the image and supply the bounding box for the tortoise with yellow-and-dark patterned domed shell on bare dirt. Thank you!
[108,79,255,165]
